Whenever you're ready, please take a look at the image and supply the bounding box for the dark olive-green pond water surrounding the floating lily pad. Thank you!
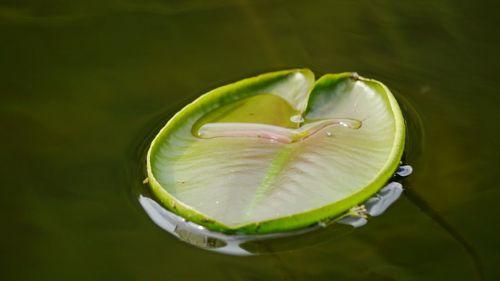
[0,0,500,281]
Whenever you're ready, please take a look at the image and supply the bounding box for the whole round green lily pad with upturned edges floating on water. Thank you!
[147,69,405,234]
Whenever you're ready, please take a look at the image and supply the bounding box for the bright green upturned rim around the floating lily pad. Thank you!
[146,69,405,234]
